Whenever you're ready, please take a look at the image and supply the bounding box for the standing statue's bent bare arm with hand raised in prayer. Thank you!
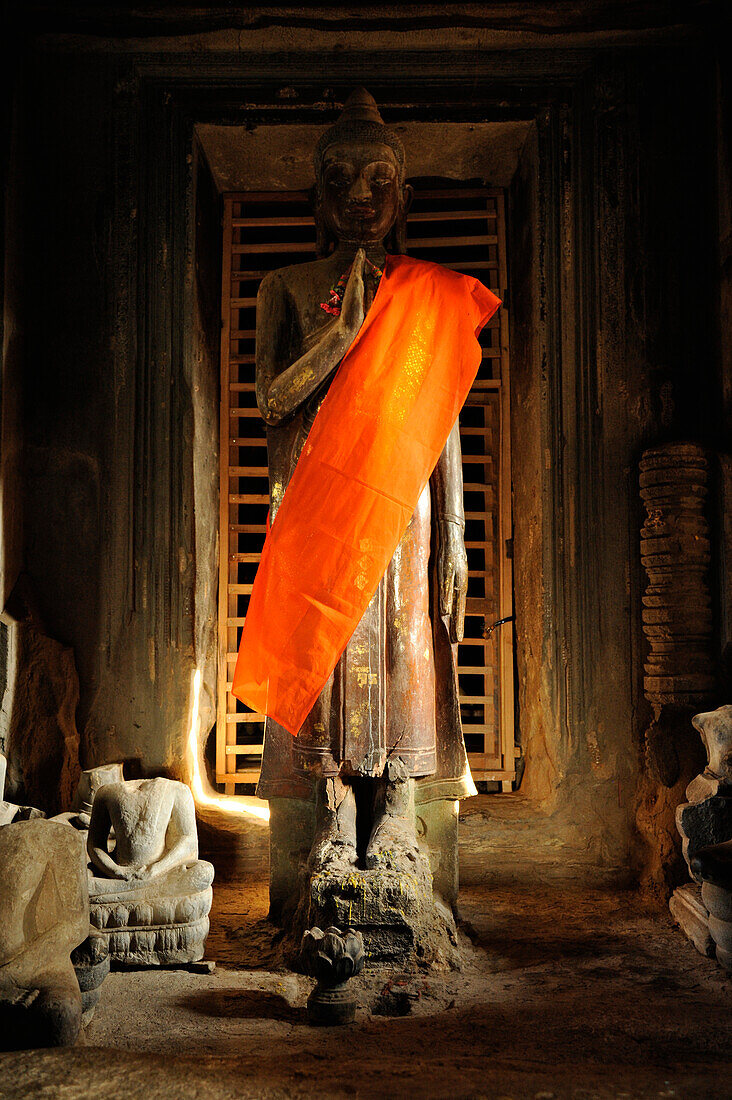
[256,252,365,425]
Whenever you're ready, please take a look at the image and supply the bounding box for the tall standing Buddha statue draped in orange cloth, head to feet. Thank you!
[233,89,500,872]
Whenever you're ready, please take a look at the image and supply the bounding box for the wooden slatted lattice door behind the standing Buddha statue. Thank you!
[216,185,515,794]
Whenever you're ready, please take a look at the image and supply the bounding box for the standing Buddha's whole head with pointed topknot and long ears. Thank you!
[314,88,411,255]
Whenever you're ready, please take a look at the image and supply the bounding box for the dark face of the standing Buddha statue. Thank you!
[319,139,404,246]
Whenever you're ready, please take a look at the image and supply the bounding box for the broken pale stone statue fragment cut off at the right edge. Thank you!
[669,706,732,970]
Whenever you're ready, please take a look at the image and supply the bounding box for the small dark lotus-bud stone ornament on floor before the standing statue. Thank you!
[302,926,365,1026]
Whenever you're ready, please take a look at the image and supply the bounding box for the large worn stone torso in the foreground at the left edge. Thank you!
[0,820,89,1051]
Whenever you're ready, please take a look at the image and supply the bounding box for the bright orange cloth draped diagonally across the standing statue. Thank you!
[231,256,501,735]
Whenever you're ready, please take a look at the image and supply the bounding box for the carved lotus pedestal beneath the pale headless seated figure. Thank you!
[90,860,214,966]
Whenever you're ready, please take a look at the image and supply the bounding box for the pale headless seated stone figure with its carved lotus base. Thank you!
[87,779,214,966]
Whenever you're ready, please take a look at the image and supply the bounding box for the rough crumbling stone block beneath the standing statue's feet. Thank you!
[295,859,459,967]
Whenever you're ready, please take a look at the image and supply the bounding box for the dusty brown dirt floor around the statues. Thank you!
[0,799,732,1100]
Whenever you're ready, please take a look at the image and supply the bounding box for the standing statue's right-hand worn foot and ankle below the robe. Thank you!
[365,757,419,871]
